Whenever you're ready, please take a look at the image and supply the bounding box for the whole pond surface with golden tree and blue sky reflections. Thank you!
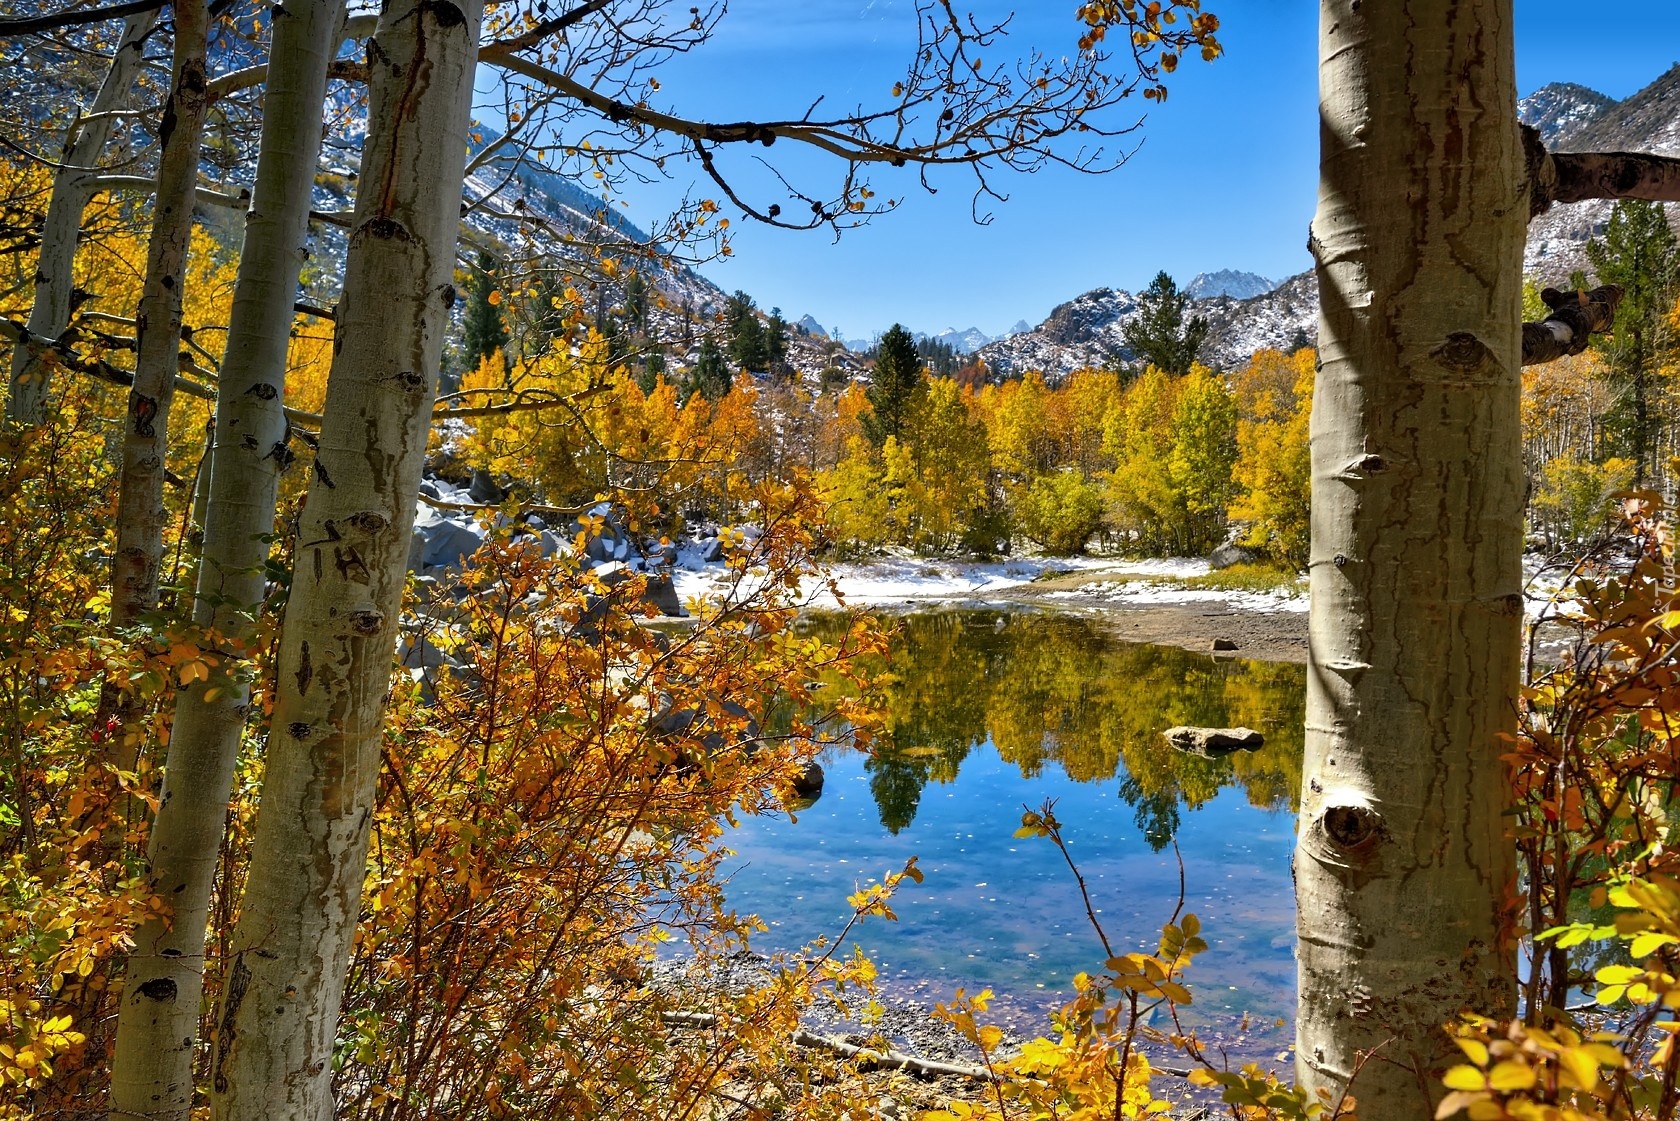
[727,610,1305,1059]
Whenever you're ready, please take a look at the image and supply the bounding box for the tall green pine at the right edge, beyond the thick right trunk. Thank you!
[1586,200,1680,487]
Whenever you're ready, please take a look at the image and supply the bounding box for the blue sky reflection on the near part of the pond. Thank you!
[727,617,1299,1059]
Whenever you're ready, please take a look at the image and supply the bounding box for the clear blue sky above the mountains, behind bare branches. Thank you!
[500,0,1680,338]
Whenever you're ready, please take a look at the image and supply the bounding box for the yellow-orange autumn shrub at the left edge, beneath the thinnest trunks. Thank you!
[0,398,179,1118]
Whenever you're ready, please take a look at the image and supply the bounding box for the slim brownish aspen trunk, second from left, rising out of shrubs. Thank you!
[111,0,210,627]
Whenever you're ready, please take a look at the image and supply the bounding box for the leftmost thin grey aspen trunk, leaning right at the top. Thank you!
[5,10,158,425]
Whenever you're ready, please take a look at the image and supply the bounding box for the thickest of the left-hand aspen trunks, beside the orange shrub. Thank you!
[210,0,484,1121]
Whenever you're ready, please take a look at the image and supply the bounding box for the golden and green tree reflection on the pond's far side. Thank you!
[816,612,1305,849]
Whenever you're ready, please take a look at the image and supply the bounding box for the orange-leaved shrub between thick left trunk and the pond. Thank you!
[336,484,907,1118]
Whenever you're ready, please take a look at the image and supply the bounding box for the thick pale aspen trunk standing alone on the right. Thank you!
[1295,0,1527,1121]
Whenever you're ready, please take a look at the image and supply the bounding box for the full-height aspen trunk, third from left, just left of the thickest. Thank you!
[111,0,344,1119]
